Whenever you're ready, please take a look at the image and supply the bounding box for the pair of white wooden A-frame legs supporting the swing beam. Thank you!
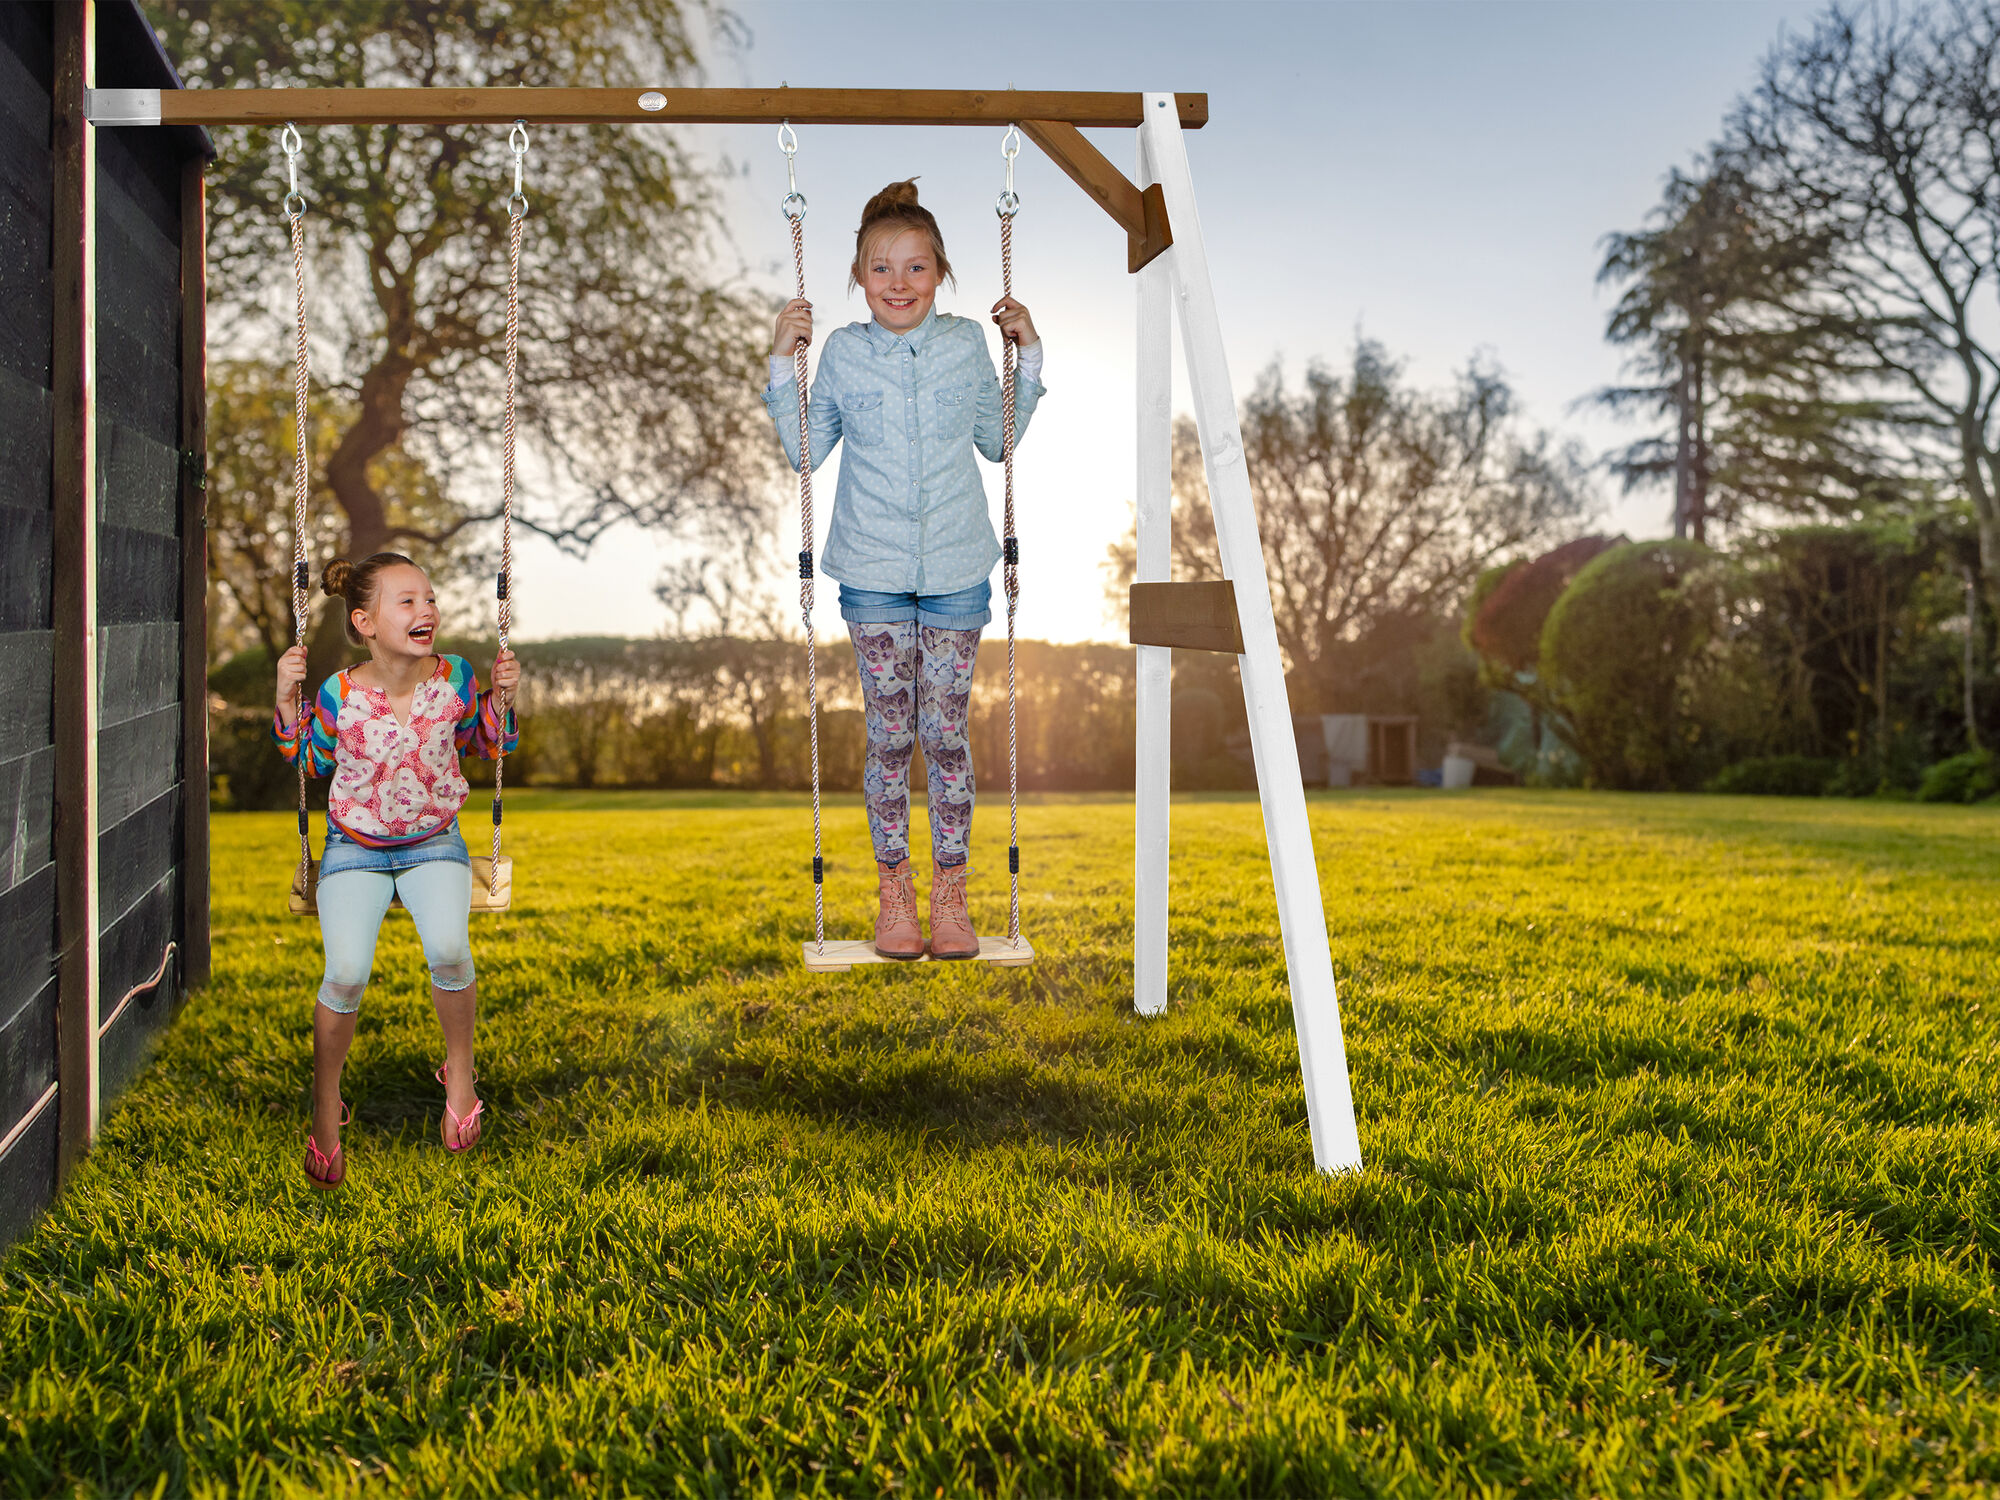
[1132,94,1362,1172]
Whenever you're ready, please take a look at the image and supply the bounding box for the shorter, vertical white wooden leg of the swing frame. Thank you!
[1132,136,1174,1016]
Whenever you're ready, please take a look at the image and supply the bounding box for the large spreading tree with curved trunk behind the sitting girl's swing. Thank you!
[154,0,770,676]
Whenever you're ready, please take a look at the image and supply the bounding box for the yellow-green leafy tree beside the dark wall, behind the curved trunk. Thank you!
[208,360,466,660]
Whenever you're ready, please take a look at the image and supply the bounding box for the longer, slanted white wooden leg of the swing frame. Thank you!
[1140,94,1362,1172]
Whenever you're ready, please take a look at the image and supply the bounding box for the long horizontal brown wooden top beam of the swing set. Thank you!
[141,88,1208,130]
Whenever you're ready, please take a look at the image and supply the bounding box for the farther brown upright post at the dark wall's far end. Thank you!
[180,158,208,994]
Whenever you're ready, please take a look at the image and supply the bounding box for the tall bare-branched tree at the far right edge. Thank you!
[1726,2,2000,604]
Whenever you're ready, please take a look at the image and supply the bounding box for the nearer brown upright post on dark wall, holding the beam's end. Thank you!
[50,0,98,1180]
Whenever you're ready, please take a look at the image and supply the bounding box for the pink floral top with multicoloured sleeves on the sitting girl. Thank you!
[272,656,520,848]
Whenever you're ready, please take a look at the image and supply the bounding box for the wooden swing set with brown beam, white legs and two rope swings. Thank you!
[86,88,1362,1172]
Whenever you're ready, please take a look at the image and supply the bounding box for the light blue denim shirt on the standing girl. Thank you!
[764,308,1044,594]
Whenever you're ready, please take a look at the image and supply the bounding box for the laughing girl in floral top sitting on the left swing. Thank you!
[272,552,520,1188]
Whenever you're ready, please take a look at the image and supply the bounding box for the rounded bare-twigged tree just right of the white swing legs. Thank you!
[1112,340,1590,712]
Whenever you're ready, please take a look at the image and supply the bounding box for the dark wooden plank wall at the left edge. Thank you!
[0,0,208,1244]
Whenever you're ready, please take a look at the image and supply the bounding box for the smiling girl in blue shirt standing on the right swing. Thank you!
[764,180,1044,958]
